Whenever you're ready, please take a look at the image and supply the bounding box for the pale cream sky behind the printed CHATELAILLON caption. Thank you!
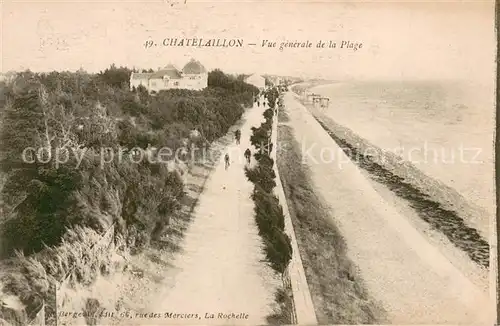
[0,0,496,83]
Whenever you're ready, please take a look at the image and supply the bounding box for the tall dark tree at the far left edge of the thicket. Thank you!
[1,82,85,255]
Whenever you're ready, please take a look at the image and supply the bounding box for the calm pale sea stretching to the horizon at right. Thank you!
[311,80,495,216]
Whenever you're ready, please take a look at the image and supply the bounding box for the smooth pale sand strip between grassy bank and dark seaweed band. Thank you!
[285,93,492,324]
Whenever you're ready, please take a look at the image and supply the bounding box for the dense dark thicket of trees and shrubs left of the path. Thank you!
[0,65,255,320]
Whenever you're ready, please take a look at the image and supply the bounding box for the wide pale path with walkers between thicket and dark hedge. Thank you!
[133,98,281,325]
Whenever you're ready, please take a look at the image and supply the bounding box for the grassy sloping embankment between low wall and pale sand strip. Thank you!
[278,111,387,324]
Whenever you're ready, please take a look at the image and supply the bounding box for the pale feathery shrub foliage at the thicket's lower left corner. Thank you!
[0,227,120,324]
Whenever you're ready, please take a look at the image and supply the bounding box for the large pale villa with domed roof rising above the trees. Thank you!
[130,59,208,92]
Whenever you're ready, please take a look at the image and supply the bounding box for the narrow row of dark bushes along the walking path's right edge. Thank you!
[245,88,296,325]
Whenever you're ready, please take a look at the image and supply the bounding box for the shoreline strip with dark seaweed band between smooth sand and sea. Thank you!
[288,85,495,291]
